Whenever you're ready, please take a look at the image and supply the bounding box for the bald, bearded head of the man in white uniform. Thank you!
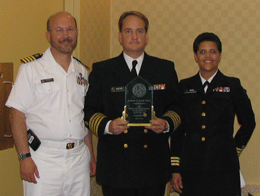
[46,13,78,54]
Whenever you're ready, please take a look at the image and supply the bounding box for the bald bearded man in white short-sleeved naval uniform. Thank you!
[6,12,96,196]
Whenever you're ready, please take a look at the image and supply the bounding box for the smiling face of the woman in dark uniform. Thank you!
[194,41,221,75]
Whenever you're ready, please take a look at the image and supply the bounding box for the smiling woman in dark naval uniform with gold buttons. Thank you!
[171,33,255,196]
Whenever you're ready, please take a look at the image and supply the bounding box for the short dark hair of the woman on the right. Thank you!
[193,32,222,53]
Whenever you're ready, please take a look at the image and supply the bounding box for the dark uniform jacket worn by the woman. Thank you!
[171,70,255,172]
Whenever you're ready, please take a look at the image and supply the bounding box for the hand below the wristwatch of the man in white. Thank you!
[20,157,40,183]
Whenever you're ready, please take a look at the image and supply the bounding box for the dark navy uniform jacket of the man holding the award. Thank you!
[85,53,181,188]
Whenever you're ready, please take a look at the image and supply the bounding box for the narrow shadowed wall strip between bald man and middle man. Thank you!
[80,0,110,67]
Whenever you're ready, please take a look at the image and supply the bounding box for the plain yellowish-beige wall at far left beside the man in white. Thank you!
[0,0,63,196]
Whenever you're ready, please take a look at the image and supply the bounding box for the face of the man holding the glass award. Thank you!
[119,15,148,58]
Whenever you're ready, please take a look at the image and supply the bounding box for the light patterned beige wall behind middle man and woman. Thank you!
[110,0,260,188]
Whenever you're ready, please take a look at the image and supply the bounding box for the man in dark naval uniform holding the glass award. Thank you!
[85,11,181,196]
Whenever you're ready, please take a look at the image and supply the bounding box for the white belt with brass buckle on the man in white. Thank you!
[41,139,84,149]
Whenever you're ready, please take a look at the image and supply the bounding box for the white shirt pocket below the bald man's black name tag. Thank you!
[35,82,61,110]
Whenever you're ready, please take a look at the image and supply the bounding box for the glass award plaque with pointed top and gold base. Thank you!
[122,76,156,126]
